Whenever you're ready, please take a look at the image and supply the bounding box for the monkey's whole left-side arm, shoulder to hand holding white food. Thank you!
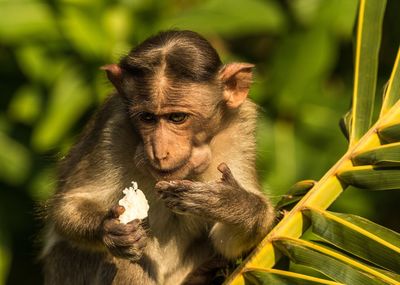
[46,96,144,257]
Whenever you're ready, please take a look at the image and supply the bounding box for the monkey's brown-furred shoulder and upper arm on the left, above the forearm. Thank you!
[58,94,138,189]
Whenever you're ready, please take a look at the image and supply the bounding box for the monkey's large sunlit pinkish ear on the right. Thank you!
[219,62,254,109]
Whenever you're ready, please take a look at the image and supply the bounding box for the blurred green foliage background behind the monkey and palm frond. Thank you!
[0,0,400,285]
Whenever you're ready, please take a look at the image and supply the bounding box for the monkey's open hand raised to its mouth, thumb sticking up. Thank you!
[156,163,253,221]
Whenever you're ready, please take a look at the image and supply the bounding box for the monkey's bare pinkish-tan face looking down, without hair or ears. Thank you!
[130,82,218,180]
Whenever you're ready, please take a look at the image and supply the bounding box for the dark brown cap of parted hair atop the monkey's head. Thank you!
[120,30,222,83]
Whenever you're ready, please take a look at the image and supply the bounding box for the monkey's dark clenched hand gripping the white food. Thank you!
[102,205,147,261]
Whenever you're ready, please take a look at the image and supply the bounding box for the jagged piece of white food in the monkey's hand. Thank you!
[118,181,149,224]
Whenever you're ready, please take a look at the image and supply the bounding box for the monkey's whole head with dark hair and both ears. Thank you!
[103,31,253,180]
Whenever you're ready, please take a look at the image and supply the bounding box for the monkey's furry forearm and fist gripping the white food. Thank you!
[50,186,147,261]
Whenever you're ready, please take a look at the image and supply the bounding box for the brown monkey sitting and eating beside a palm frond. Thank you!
[41,30,275,285]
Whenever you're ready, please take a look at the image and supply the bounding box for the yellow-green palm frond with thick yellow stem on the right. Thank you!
[226,0,400,285]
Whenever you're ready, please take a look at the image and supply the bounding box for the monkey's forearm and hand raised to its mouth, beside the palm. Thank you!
[156,164,274,258]
